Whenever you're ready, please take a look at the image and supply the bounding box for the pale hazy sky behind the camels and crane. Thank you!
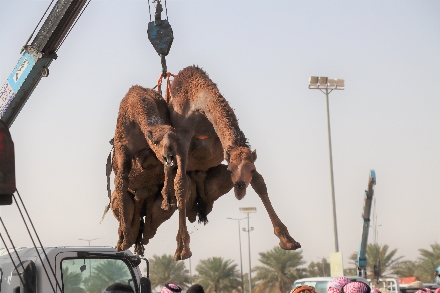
[0,0,440,273]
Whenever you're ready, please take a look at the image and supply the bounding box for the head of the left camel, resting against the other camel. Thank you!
[147,126,177,167]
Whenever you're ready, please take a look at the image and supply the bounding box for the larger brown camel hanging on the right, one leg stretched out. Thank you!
[169,66,301,260]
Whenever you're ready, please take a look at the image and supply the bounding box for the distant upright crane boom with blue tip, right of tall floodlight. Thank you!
[356,170,376,278]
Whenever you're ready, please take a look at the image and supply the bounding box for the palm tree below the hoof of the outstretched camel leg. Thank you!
[253,246,306,293]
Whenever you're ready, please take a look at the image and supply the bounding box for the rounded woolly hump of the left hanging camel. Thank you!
[119,85,170,126]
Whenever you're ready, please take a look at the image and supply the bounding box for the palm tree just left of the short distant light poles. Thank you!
[195,257,241,293]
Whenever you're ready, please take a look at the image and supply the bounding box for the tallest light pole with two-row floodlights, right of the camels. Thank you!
[309,76,344,252]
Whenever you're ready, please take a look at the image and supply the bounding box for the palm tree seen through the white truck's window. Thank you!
[84,259,131,293]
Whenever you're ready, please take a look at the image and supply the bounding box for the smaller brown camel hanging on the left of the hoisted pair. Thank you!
[111,86,177,251]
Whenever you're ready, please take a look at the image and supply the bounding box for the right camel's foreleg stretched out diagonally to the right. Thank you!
[251,171,301,250]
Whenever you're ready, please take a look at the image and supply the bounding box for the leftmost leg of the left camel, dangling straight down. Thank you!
[111,146,134,251]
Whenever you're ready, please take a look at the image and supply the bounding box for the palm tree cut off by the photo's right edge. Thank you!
[417,242,440,282]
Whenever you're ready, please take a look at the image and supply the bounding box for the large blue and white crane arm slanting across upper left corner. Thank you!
[0,0,87,128]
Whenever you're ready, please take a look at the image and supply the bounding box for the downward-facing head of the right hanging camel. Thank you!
[225,147,257,199]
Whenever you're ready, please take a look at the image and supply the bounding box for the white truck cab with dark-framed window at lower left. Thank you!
[0,246,151,293]
